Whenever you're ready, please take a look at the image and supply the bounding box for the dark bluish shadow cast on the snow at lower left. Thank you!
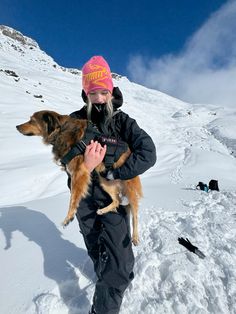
[0,206,94,314]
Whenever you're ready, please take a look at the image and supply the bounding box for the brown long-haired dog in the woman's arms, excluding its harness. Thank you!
[16,110,142,245]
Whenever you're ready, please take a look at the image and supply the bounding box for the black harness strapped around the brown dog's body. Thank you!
[61,121,128,168]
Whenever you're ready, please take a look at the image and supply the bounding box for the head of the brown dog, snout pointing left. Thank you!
[16,110,68,141]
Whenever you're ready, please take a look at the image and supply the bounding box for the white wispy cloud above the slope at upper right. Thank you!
[128,0,236,106]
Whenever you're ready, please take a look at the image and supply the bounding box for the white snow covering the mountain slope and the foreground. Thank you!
[0,29,236,314]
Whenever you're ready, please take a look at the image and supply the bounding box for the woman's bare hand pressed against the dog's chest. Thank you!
[84,140,107,172]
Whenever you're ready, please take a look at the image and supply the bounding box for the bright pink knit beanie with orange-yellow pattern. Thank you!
[82,56,113,95]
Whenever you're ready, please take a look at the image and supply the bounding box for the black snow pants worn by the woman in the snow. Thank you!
[76,175,134,314]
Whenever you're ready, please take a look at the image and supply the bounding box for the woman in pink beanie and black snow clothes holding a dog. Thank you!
[71,56,156,314]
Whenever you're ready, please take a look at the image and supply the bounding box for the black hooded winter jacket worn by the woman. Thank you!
[71,88,156,180]
